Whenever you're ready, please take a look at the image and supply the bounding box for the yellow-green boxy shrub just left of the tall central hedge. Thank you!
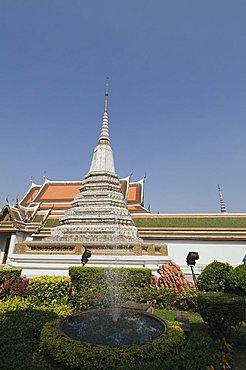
[28,276,70,304]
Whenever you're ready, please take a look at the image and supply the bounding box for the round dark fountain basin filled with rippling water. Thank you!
[60,309,167,346]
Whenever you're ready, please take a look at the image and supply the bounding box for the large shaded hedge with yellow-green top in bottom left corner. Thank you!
[0,297,71,370]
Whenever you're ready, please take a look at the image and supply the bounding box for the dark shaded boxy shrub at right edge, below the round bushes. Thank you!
[197,292,246,338]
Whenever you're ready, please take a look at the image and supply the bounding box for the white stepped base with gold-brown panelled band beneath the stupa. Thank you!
[7,241,170,277]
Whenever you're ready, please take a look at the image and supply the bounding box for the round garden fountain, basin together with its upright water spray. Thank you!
[60,268,167,347]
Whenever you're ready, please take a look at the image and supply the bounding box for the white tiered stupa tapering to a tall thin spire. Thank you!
[51,83,143,248]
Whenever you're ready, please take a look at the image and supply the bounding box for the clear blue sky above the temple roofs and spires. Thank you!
[0,0,246,213]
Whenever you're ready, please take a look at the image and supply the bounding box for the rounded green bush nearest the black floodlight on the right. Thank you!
[197,261,233,292]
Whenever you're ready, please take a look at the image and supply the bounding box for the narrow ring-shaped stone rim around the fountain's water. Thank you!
[58,308,168,348]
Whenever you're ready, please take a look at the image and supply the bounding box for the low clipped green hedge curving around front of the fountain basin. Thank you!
[39,320,184,370]
